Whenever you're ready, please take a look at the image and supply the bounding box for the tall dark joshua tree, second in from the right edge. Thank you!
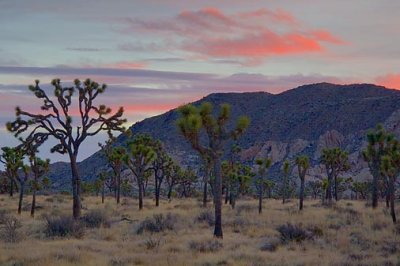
[362,124,394,208]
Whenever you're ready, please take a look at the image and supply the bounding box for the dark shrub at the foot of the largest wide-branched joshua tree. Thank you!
[45,216,85,238]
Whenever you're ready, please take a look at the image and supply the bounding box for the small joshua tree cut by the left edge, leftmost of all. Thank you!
[0,147,24,197]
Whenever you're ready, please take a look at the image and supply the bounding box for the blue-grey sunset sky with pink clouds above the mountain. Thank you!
[0,0,400,162]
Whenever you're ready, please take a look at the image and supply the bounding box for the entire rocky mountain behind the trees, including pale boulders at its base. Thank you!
[51,83,400,188]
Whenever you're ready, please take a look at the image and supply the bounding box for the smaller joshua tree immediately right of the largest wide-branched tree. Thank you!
[99,139,126,204]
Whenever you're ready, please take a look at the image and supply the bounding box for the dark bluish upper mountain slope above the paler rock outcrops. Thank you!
[47,83,400,187]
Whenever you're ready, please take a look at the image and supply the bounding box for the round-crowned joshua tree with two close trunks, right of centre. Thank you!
[321,148,350,204]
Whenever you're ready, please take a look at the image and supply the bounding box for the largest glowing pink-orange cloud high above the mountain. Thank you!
[120,7,345,65]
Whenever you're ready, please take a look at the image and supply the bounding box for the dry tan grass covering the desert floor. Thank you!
[0,195,400,266]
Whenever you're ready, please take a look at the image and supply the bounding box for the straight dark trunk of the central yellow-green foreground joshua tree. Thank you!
[214,155,223,238]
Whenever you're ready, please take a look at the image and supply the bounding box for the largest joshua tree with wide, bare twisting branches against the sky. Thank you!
[7,79,126,219]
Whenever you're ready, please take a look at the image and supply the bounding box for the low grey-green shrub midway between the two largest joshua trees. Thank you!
[136,213,178,234]
